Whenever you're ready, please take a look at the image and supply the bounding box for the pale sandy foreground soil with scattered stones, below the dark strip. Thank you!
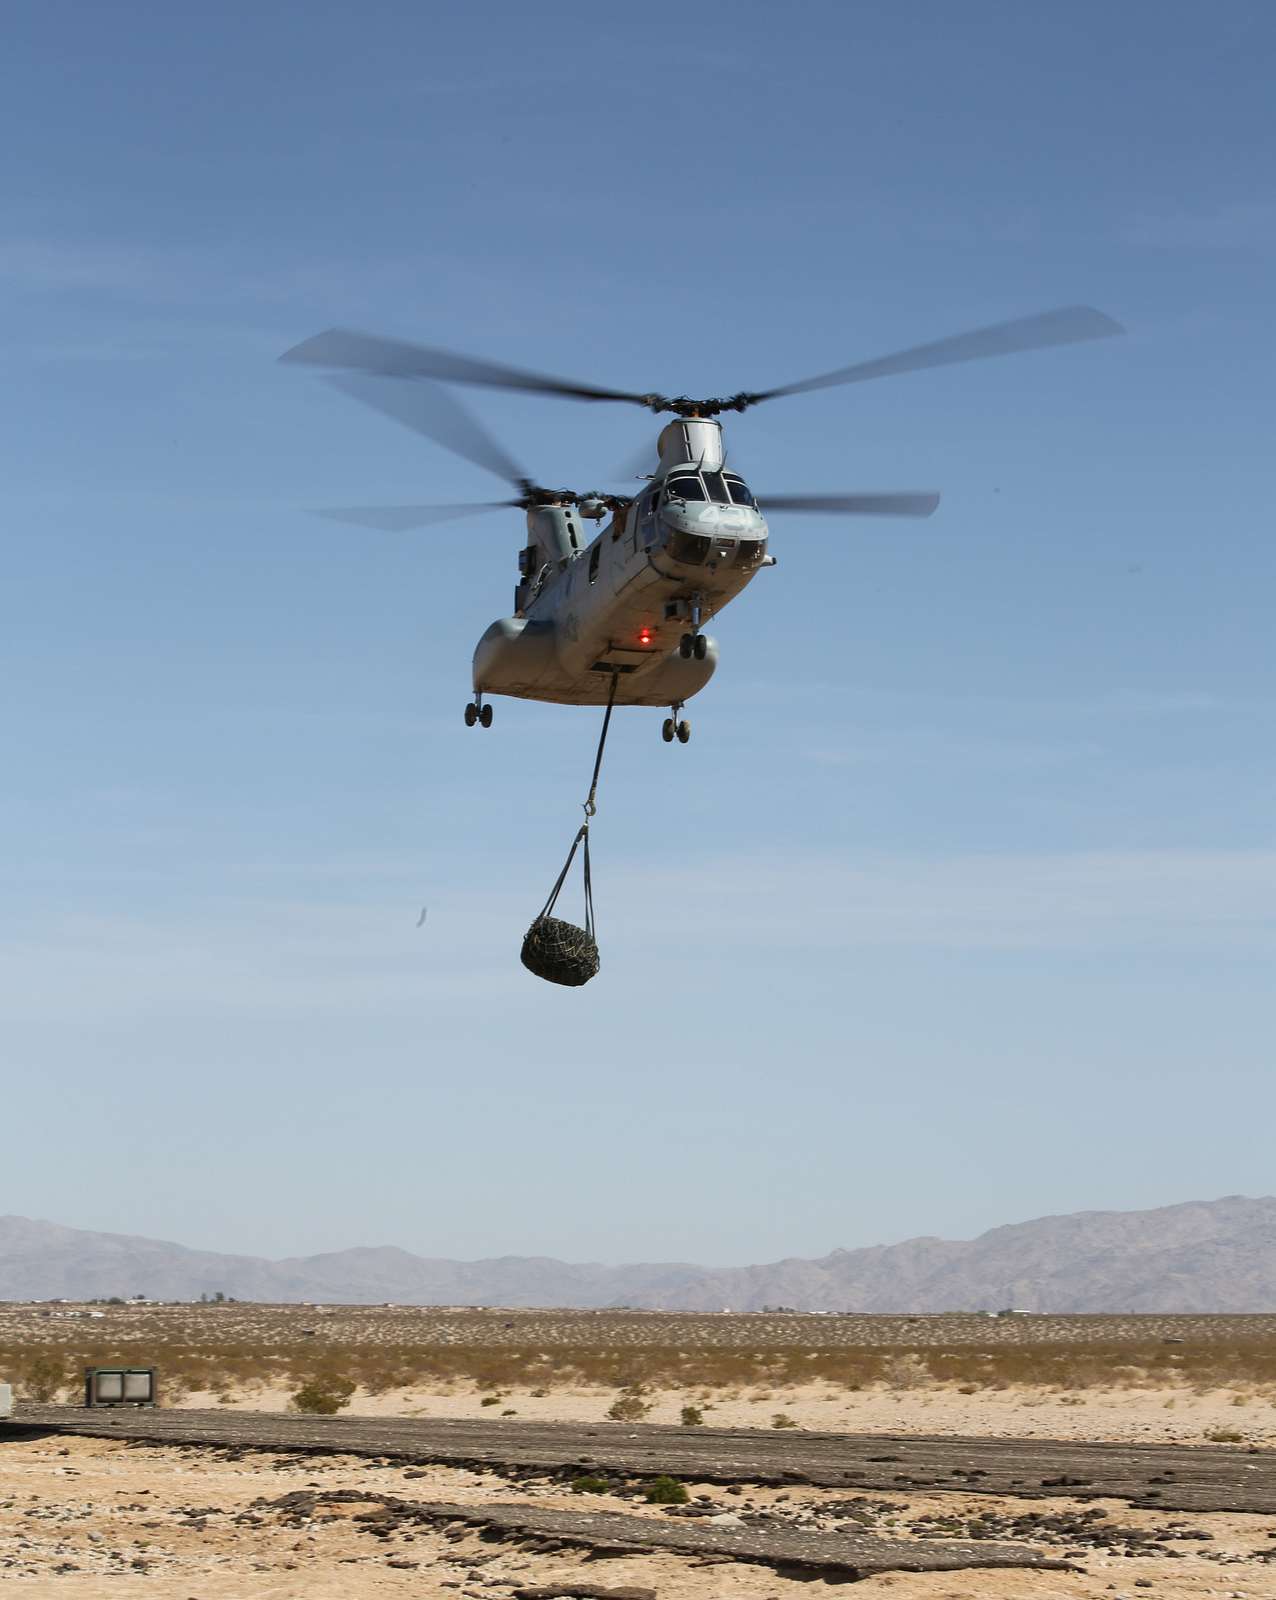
[0,1437,1276,1600]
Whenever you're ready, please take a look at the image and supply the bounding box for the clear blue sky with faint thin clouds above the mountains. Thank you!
[0,0,1276,1262]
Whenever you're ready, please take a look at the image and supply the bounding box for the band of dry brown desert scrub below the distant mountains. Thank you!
[0,1304,1276,1400]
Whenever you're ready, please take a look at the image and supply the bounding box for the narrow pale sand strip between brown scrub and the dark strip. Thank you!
[165,1384,1276,1446]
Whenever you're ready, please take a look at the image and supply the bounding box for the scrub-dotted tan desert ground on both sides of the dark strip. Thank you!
[0,1306,1276,1600]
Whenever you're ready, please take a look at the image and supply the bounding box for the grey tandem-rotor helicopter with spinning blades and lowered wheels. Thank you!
[281,306,1122,744]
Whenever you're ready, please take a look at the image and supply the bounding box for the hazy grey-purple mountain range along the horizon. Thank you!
[0,1195,1276,1312]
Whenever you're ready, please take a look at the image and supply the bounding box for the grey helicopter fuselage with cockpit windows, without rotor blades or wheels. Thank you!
[473,419,772,706]
